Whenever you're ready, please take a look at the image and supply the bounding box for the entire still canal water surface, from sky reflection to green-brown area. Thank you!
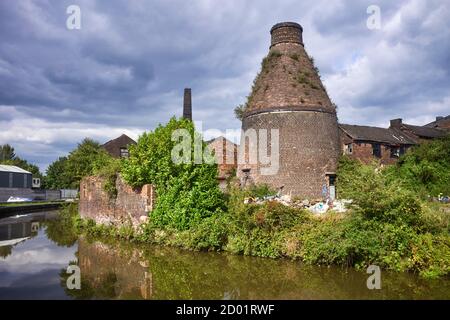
[0,212,450,299]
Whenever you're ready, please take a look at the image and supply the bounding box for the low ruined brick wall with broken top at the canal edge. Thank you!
[79,176,156,226]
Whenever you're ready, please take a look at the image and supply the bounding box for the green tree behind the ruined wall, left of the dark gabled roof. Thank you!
[64,138,112,188]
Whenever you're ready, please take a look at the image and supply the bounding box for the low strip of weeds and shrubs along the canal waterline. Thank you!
[62,188,450,278]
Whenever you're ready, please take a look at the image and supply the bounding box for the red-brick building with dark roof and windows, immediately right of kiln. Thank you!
[339,124,416,164]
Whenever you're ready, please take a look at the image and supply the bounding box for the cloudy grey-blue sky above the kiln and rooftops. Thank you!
[0,0,450,170]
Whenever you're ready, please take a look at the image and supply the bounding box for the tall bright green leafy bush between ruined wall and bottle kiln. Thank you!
[122,118,224,230]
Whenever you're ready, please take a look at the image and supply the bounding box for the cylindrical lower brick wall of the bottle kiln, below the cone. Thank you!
[237,111,340,199]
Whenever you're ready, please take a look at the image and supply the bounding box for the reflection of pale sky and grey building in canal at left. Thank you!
[0,212,77,299]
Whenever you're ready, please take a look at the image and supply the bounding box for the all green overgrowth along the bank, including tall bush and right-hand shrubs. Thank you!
[66,119,450,278]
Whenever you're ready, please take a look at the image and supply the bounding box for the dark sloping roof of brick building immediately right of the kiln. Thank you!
[339,124,416,145]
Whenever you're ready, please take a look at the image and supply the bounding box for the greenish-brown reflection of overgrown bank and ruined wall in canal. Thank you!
[68,238,450,299]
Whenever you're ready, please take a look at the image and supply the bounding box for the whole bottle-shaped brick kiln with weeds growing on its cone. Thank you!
[238,22,340,198]
